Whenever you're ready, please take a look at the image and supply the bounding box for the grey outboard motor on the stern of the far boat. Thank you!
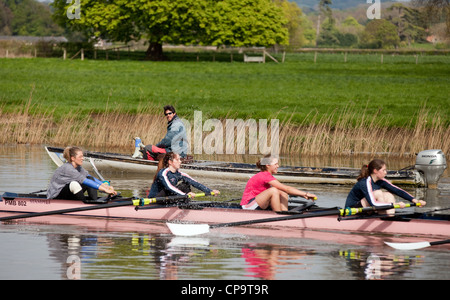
[415,150,447,189]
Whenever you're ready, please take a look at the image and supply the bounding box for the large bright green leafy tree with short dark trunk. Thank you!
[53,0,288,60]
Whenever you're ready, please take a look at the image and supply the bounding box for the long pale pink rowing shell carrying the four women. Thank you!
[0,192,450,236]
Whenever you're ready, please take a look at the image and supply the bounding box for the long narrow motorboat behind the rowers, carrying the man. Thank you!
[45,147,425,186]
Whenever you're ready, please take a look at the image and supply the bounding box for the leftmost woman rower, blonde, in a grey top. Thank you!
[47,147,117,200]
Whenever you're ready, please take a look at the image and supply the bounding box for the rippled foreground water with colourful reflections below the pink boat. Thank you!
[0,223,450,280]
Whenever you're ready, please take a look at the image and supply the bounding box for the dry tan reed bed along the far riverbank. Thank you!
[0,101,450,156]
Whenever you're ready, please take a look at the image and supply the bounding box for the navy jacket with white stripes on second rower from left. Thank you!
[148,168,212,198]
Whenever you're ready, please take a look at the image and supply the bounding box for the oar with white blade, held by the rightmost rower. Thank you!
[166,203,420,236]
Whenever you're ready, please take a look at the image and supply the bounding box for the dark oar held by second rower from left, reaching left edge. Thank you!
[0,193,213,221]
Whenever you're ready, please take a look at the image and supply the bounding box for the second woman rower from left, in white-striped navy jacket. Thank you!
[148,152,219,198]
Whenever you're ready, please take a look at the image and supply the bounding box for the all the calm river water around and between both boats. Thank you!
[0,145,450,280]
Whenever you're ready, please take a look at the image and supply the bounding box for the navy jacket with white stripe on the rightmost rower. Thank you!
[345,176,414,207]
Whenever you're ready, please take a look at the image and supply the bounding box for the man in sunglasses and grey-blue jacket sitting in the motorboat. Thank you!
[137,105,188,160]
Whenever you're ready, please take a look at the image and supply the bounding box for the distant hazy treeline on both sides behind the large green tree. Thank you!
[0,0,450,50]
